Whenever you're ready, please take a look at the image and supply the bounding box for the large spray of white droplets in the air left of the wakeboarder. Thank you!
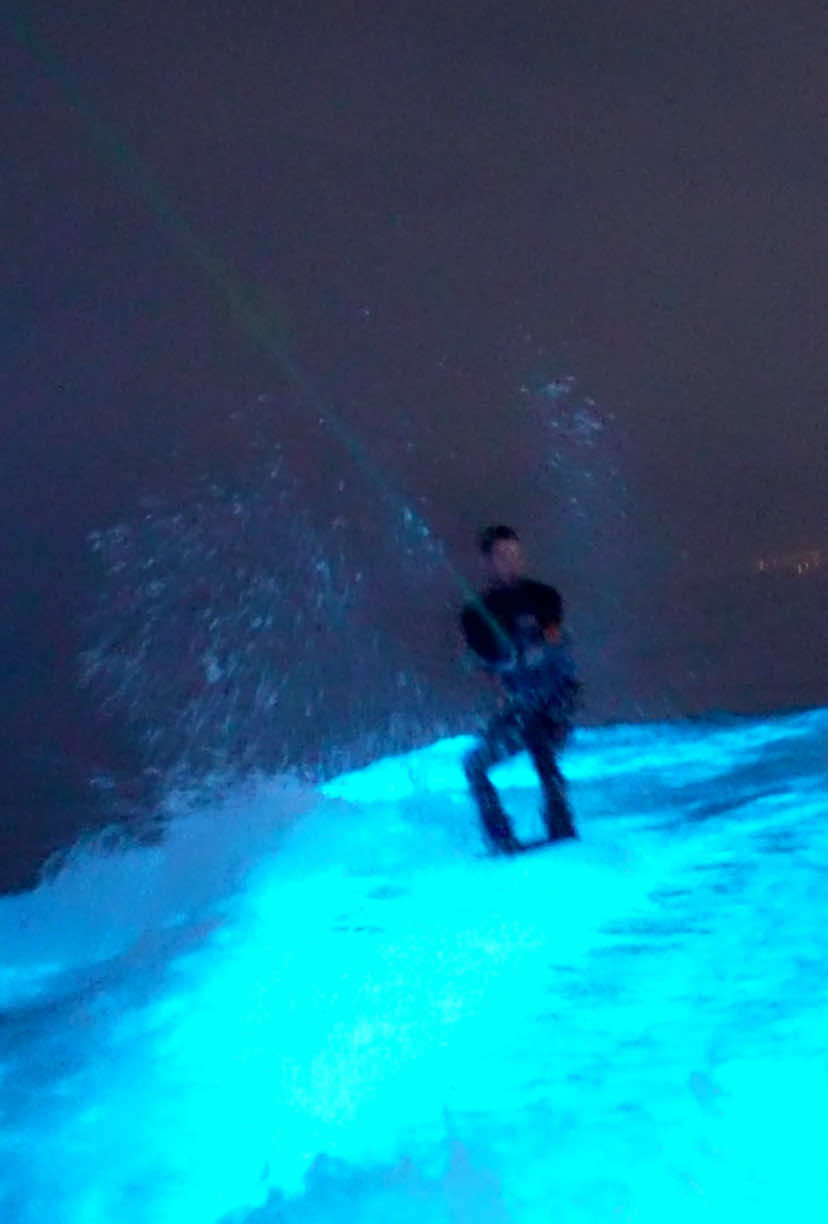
[81,438,455,788]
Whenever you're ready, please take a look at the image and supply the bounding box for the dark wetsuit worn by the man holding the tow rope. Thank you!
[461,579,578,851]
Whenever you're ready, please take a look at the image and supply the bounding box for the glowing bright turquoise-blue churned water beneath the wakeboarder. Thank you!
[0,711,828,1224]
